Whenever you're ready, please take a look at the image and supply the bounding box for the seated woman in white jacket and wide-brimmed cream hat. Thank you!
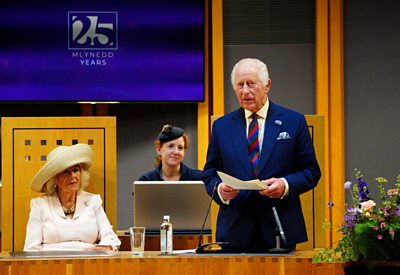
[24,144,121,251]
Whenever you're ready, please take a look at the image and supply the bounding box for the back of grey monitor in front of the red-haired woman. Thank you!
[133,181,211,234]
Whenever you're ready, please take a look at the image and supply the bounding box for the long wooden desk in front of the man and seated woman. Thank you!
[0,251,344,275]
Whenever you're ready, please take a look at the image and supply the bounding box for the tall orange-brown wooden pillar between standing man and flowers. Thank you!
[315,0,345,246]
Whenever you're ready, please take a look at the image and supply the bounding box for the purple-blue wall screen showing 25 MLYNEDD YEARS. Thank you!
[0,0,205,102]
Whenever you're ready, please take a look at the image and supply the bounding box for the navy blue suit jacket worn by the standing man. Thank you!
[203,102,321,249]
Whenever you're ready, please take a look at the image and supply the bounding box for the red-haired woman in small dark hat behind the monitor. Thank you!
[139,125,202,181]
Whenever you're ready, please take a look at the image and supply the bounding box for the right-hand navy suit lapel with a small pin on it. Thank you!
[257,101,283,177]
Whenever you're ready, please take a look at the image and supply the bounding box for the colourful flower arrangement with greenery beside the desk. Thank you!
[313,169,400,262]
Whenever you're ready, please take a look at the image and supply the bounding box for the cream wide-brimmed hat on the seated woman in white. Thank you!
[31,144,93,192]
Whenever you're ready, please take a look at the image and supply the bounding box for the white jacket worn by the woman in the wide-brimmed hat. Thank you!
[24,191,121,251]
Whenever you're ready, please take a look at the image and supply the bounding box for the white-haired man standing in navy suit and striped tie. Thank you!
[203,58,321,252]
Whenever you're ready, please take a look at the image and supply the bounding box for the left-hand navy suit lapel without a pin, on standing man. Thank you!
[230,108,253,175]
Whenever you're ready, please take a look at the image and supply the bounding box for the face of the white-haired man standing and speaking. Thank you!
[234,63,271,113]
